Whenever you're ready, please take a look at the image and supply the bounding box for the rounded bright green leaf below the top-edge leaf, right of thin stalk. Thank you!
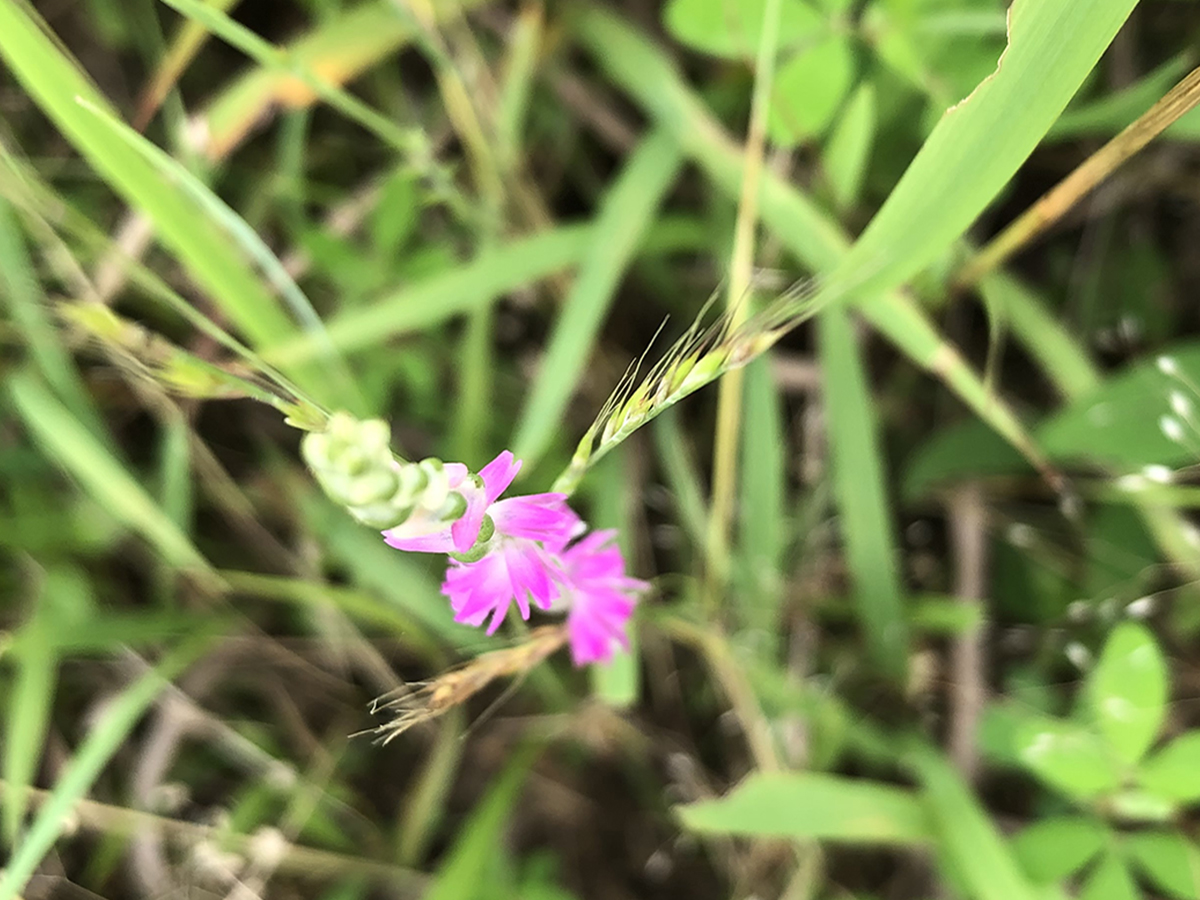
[767,35,854,146]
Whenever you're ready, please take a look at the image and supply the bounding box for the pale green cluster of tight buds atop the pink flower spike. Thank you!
[300,413,467,530]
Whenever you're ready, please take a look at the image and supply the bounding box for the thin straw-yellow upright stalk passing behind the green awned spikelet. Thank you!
[702,0,780,608]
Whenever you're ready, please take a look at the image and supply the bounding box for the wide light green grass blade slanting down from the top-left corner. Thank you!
[0,0,293,346]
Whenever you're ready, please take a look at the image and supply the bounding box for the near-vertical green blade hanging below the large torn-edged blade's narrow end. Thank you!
[817,306,908,684]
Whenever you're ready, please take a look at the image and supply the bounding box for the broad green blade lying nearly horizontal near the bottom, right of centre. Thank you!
[677,772,930,845]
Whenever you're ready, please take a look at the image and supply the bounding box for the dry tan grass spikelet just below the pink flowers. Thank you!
[364,625,566,744]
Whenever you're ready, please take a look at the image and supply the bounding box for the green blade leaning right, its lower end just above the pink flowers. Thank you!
[511,128,683,464]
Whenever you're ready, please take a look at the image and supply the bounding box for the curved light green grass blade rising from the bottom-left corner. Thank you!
[0,634,212,900]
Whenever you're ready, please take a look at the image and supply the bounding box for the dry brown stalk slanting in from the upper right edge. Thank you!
[954,67,1200,288]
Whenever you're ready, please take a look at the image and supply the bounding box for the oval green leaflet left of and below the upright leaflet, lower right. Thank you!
[1015,719,1121,800]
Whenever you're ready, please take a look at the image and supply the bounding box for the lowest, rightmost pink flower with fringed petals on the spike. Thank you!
[558,530,649,666]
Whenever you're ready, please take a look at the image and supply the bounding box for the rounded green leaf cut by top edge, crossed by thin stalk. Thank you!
[664,0,826,59]
